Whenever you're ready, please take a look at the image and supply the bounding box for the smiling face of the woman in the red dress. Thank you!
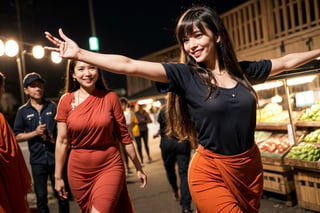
[72,61,99,90]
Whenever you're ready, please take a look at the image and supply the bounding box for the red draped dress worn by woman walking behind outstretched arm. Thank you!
[56,90,133,213]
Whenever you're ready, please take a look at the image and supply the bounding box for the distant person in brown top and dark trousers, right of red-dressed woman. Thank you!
[135,104,152,163]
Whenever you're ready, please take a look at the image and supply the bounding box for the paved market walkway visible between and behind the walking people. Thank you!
[24,124,312,213]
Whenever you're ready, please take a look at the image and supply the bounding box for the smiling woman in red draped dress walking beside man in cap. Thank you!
[55,60,147,213]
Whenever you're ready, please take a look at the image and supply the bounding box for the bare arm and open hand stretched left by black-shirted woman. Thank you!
[45,29,168,83]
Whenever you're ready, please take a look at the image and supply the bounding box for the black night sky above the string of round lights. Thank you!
[0,0,246,103]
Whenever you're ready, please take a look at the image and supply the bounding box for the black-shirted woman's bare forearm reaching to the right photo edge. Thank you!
[270,49,320,76]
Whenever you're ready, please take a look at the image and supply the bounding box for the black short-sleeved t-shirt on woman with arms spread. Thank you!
[156,60,272,155]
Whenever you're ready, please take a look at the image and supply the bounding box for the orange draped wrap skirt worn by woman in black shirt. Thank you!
[189,145,263,213]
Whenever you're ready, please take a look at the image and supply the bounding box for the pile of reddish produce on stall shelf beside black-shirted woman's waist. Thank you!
[257,134,291,154]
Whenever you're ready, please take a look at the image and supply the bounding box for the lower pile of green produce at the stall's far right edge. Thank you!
[286,142,320,161]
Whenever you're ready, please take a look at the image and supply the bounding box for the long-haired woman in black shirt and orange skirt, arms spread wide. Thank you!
[45,5,320,213]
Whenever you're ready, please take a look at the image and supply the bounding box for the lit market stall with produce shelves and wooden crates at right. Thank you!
[255,68,320,211]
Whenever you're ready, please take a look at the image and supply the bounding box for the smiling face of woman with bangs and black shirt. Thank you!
[183,25,220,67]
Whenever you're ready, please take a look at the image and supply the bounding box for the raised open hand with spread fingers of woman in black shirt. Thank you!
[44,28,80,59]
